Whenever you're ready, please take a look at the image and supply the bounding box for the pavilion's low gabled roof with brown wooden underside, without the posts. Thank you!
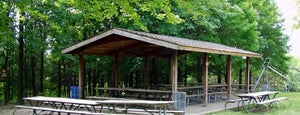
[62,28,262,58]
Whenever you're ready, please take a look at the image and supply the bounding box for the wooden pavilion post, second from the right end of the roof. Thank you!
[226,55,232,100]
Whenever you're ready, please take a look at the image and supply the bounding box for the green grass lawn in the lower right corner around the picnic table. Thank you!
[210,92,300,115]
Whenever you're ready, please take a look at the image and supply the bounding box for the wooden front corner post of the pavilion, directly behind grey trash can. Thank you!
[170,51,178,92]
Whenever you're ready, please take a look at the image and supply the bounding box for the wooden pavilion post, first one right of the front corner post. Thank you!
[203,53,209,107]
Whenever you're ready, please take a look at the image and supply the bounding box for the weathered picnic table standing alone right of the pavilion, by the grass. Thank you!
[238,91,279,112]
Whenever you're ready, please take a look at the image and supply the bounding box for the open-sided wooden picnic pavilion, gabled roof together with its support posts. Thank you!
[62,28,262,106]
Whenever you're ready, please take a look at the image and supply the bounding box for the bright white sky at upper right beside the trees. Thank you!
[275,0,300,57]
